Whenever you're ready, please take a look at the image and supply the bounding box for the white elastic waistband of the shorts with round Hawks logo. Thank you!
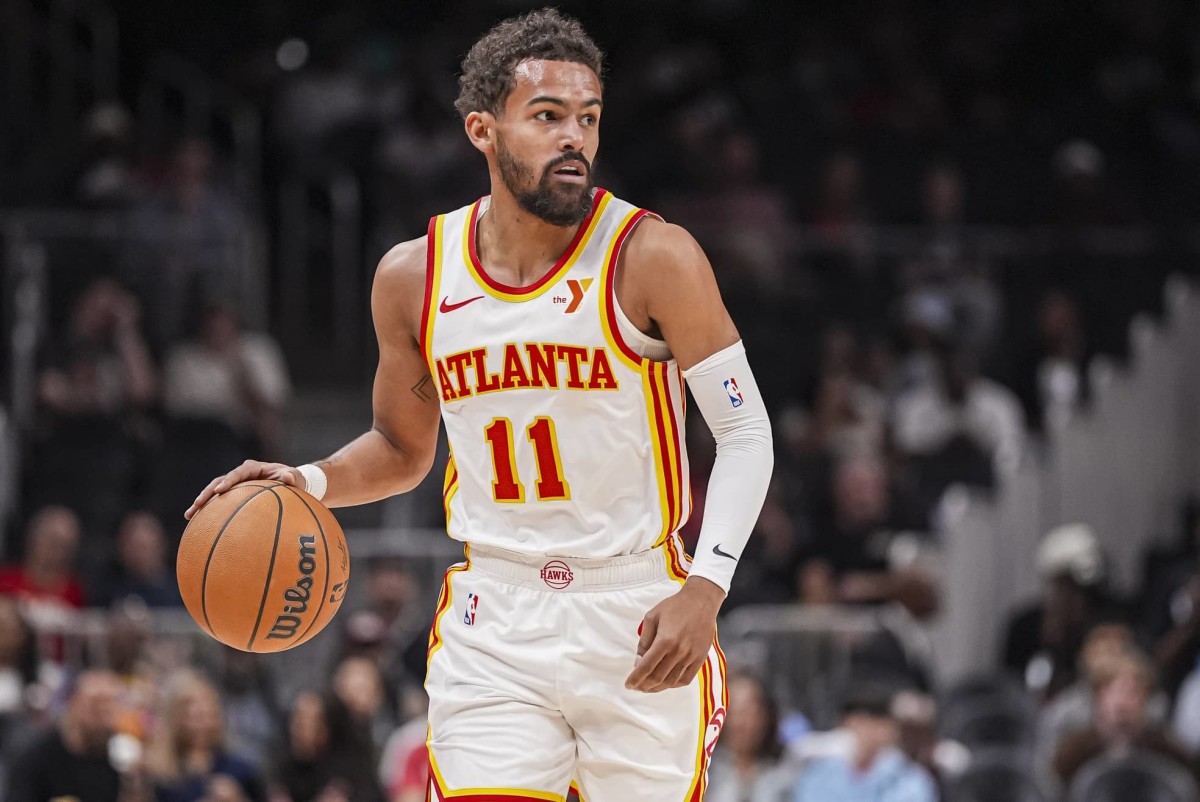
[468,545,685,592]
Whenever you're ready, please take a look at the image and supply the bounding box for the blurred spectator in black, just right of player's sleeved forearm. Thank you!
[797,457,938,618]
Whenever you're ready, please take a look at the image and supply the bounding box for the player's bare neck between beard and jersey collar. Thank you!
[475,192,578,287]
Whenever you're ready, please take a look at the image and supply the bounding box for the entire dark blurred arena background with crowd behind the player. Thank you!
[0,0,1200,802]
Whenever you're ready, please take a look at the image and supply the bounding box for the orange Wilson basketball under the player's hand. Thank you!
[175,480,350,652]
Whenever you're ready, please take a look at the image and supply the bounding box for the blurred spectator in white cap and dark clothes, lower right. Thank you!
[1004,523,1116,699]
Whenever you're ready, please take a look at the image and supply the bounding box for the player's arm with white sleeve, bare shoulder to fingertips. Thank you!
[618,219,774,692]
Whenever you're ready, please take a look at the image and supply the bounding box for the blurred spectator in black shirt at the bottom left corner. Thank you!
[5,671,130,802]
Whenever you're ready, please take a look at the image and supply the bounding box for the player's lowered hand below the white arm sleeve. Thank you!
[625,576,725,694]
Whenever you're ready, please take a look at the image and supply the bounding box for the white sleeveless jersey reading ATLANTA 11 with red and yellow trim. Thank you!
[421,190,691,558]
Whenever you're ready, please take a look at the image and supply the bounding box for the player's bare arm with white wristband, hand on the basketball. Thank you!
[185,238,439,519]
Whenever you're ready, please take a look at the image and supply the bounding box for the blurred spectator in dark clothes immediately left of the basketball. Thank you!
[97,510,184,608]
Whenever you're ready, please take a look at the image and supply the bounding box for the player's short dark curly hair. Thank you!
[454,8,604,119]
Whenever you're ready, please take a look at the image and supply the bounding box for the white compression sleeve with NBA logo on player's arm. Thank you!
[684,340,775,591]
